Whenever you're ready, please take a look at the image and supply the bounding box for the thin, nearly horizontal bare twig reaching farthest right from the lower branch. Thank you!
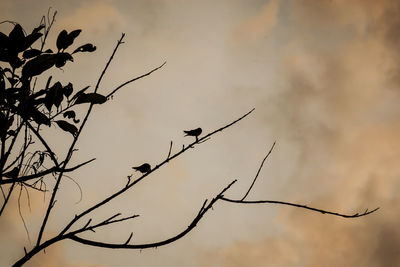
[221,197,379,218]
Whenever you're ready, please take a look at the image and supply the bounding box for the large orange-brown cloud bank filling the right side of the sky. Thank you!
[200,1,400,267]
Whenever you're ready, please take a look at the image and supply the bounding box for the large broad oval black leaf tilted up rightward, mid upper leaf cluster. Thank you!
[22,54,57,78]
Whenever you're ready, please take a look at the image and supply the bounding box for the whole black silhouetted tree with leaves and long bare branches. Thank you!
[0,13,377,266]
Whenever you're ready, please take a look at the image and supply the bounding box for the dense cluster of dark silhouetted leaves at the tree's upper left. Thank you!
[0,24,107,140]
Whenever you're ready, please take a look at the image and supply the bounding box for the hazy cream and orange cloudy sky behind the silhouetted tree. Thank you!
[0,0,400,267]
